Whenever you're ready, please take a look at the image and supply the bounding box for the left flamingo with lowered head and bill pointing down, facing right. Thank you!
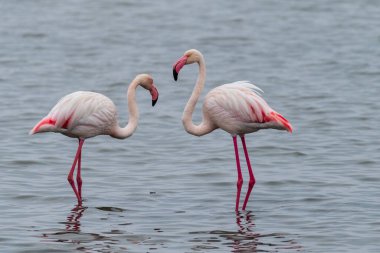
[29,74,158,206]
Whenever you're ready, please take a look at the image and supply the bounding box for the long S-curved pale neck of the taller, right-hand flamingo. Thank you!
[182,55,214,136]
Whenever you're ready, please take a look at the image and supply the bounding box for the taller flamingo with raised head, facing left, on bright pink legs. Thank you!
[173,49,292,211]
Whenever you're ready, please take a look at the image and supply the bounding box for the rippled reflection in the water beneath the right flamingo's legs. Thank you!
[190,211,302,252]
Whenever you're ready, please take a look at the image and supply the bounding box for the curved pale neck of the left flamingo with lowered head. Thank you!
[112,80,139,139]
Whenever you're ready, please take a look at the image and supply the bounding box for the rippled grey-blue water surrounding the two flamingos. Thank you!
[0,0,380,252]
